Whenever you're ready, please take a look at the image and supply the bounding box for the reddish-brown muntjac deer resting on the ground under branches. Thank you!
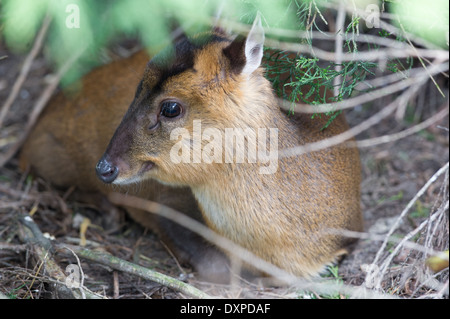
[21,18,362,279]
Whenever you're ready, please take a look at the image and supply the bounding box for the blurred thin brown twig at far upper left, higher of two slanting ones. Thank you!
[0,16,52,127]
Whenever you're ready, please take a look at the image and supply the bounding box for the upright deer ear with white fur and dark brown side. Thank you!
[223,13,264,75]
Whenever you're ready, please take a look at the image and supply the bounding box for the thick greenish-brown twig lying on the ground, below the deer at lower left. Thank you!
[60,245,211,299]
